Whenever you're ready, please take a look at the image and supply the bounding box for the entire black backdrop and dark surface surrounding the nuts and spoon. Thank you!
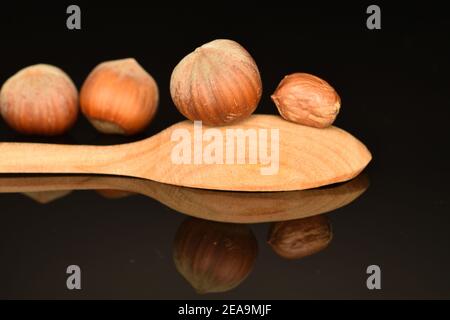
[0,1,450,299]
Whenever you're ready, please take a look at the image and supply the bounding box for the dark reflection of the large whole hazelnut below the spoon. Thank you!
[173,218,257,293]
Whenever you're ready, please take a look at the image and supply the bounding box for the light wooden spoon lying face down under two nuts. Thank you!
[0,115,371,191]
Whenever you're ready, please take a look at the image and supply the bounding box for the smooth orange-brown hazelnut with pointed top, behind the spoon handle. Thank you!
[80,58,159,135]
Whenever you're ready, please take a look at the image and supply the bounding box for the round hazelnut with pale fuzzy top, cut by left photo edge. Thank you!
[0,64,78,136]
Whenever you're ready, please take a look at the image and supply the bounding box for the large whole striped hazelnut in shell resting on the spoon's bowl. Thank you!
[170,39,262,125]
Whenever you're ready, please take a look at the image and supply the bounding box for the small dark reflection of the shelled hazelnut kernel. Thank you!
[268,215,333,259]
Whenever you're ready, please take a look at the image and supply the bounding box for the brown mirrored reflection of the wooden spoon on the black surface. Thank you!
[0,175,369,223]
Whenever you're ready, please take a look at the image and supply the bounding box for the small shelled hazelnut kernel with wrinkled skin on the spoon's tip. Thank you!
[272,73,341,128]
